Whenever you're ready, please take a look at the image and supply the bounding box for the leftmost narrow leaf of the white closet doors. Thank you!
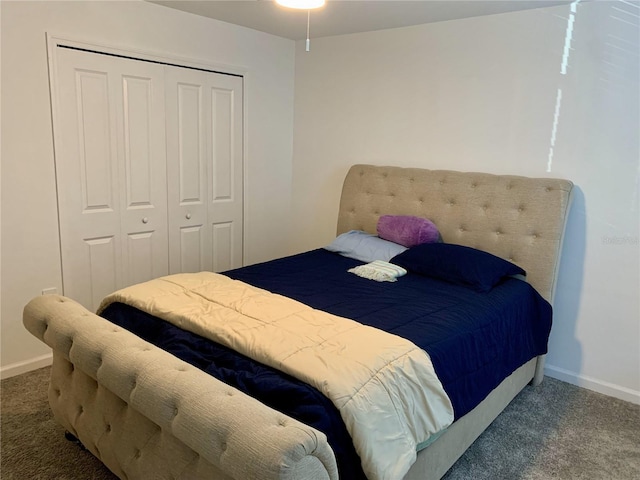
[54,50,122,309]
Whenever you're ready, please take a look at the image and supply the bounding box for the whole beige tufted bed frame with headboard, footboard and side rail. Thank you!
[24,165,573,480]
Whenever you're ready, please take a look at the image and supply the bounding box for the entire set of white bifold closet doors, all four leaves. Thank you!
[52,47,243,310]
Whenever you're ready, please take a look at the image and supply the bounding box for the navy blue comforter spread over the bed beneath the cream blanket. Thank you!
[102,249,551,479]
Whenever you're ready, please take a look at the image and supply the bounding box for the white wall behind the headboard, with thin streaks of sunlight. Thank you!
[291,2,640,403]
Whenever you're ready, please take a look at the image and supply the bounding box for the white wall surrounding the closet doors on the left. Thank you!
[0,1,295,376]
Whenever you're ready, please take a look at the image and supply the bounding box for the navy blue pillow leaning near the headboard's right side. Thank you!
[389,243,526,292]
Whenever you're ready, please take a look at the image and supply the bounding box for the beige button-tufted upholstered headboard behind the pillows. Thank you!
[338,165,573,303]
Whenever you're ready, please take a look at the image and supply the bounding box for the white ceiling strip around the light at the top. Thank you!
[148,0,571,40]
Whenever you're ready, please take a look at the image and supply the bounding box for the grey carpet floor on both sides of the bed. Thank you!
[0,367,640,480]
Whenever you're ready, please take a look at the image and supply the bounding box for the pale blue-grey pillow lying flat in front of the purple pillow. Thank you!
[324,230,407,263]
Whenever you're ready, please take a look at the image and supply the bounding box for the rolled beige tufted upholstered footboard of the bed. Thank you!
[24,295,338,480]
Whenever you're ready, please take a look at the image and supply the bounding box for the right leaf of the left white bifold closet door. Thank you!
[118,65,169,285]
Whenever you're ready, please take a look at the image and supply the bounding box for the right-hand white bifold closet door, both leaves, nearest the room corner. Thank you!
[165,67,243,273]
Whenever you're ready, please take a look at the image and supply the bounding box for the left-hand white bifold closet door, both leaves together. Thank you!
[52,47,168,310]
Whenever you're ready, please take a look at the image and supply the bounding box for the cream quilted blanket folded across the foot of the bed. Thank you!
[98,272,453,480]
